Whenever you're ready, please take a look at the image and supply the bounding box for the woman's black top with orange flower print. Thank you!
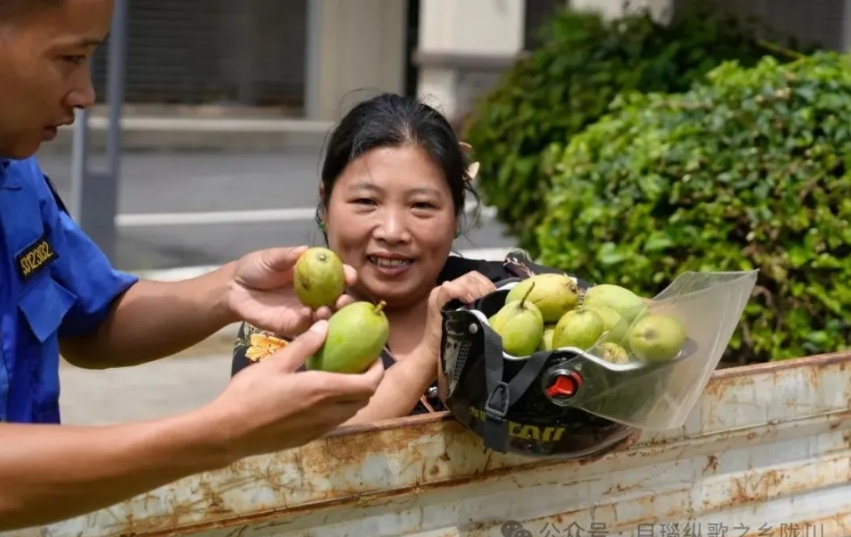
[231,251,576,415]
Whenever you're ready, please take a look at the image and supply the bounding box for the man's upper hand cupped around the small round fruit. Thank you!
[226,246,357,337]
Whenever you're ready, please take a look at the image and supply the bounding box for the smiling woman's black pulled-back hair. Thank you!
[316,93,479,239]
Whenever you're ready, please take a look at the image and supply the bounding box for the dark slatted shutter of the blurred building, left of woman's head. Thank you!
[92,0,308,110]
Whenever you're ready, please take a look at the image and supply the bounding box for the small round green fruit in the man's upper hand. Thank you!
[293,246,346,310]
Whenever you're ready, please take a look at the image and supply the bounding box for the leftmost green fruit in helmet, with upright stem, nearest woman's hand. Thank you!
[488,285,544,356]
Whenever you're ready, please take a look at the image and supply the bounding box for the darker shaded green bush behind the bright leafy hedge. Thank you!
[464,6,804,254]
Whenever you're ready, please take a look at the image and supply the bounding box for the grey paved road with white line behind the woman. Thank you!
[36,147,510,270]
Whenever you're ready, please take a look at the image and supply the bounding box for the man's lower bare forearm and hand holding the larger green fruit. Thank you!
[0,321,382,531]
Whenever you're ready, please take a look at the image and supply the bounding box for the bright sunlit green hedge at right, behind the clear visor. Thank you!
[537,53,851,362]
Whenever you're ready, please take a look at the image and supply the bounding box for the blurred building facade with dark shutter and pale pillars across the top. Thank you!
[93,0,851,124]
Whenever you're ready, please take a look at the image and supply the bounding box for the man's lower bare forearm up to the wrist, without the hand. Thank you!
[0,412,233,530]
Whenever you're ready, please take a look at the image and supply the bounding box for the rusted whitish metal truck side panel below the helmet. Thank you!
[6,354,851,537]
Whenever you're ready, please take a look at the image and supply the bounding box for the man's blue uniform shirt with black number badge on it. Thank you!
[0,158,137,423]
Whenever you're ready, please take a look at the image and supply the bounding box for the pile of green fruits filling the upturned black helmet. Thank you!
[488,274,687,364]
